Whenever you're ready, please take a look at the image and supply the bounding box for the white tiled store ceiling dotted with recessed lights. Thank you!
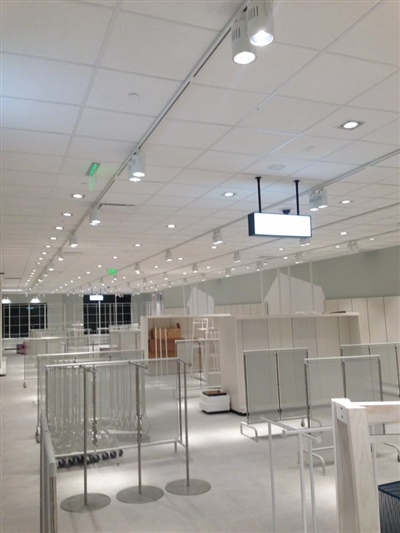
[0,0,400,294]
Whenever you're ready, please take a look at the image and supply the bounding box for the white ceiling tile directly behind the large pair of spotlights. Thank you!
[195,35,317,94]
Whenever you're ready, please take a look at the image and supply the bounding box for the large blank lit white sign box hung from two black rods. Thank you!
[248,213,312,237]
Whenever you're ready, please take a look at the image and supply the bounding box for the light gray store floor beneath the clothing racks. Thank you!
[0,354,400,533]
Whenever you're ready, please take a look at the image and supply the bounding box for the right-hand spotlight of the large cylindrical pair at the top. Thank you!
[246,0,274,46]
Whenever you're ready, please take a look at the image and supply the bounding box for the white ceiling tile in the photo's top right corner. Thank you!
[329,1,400,65]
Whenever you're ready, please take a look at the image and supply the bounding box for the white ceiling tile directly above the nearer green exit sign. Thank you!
[68,136,132,163]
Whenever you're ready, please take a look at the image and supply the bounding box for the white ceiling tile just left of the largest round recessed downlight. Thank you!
[240,96,337,133]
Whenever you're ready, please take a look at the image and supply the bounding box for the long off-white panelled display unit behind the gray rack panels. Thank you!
[214,313,360,414]
